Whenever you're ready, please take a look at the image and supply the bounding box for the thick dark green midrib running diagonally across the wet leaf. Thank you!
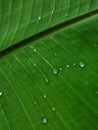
[0,9,98,58]
